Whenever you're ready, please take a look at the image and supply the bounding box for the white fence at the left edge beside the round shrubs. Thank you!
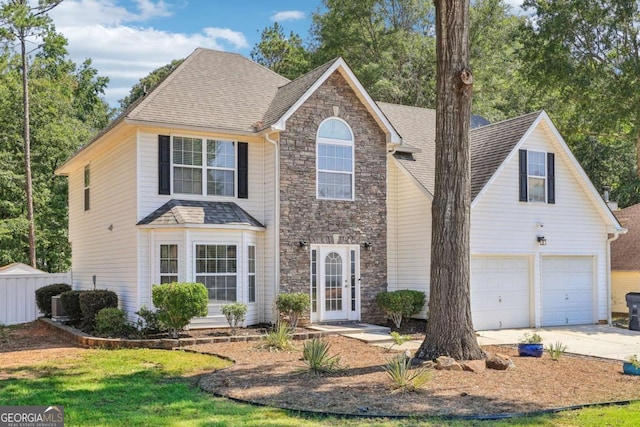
[0,272,71,325]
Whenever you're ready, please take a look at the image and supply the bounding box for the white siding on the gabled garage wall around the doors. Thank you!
[471,123,608,326]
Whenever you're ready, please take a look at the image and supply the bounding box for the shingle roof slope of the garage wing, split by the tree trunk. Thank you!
[378,102,540,200]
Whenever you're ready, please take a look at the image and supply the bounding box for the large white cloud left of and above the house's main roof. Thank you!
[45,0,249,106]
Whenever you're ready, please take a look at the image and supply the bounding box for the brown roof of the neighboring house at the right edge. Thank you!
[611,204,640,270]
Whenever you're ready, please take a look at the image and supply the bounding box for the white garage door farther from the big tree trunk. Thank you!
[541,256,594,326]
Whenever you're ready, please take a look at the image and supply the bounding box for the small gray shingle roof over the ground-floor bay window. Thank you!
[138,199,265,228]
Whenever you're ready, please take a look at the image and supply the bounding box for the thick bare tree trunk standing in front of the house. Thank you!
[416,0,484,360]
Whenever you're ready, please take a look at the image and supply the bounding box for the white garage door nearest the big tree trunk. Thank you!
[471,256,530,330]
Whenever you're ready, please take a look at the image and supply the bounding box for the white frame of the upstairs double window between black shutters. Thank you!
[169,134,240,198]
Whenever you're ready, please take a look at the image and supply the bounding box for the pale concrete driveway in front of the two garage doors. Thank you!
[478,325,640,360]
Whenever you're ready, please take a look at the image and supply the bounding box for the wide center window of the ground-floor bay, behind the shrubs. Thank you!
[195,245,238,304]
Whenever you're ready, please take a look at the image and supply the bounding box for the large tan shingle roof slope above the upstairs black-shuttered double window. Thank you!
[127,48,289,132]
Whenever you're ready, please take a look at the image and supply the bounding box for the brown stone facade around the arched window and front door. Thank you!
[280,71,387,322]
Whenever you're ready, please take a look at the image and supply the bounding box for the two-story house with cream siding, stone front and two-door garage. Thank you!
[57,49,623,328]
